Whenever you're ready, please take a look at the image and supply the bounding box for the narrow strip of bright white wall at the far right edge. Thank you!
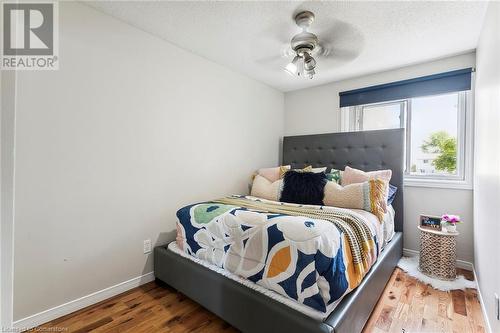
[474,2,500,332]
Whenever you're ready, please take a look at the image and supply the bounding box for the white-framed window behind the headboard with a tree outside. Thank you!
[341,91,471,188]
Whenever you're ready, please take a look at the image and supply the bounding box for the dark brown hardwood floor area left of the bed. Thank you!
[41,281,238,333]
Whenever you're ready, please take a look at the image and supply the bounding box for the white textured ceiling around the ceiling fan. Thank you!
[87,1,487,91]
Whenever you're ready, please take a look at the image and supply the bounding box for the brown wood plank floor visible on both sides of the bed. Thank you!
[40,269,485,333]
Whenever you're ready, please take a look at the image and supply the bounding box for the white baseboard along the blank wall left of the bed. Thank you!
[13,272,155,331]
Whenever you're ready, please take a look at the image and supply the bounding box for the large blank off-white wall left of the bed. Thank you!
[14,2,284,319]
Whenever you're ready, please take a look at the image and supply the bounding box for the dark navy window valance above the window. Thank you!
[339,68,472,107]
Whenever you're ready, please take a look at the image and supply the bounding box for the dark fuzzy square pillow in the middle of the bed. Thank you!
[280,171,327,205]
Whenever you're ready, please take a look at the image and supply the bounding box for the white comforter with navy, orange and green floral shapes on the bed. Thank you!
[177,196,381,312]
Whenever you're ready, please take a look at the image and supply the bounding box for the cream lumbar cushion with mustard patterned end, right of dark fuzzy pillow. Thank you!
[323,179,387,221]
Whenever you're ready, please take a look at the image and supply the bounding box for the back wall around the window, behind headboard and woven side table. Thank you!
[285,53,475,262]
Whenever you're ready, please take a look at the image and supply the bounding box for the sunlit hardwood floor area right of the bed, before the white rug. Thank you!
[363,268,486,333]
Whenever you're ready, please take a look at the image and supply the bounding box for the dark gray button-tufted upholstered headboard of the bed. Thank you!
[283,129,405,231]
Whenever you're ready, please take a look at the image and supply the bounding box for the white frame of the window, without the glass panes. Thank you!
[340,90,473,189]
